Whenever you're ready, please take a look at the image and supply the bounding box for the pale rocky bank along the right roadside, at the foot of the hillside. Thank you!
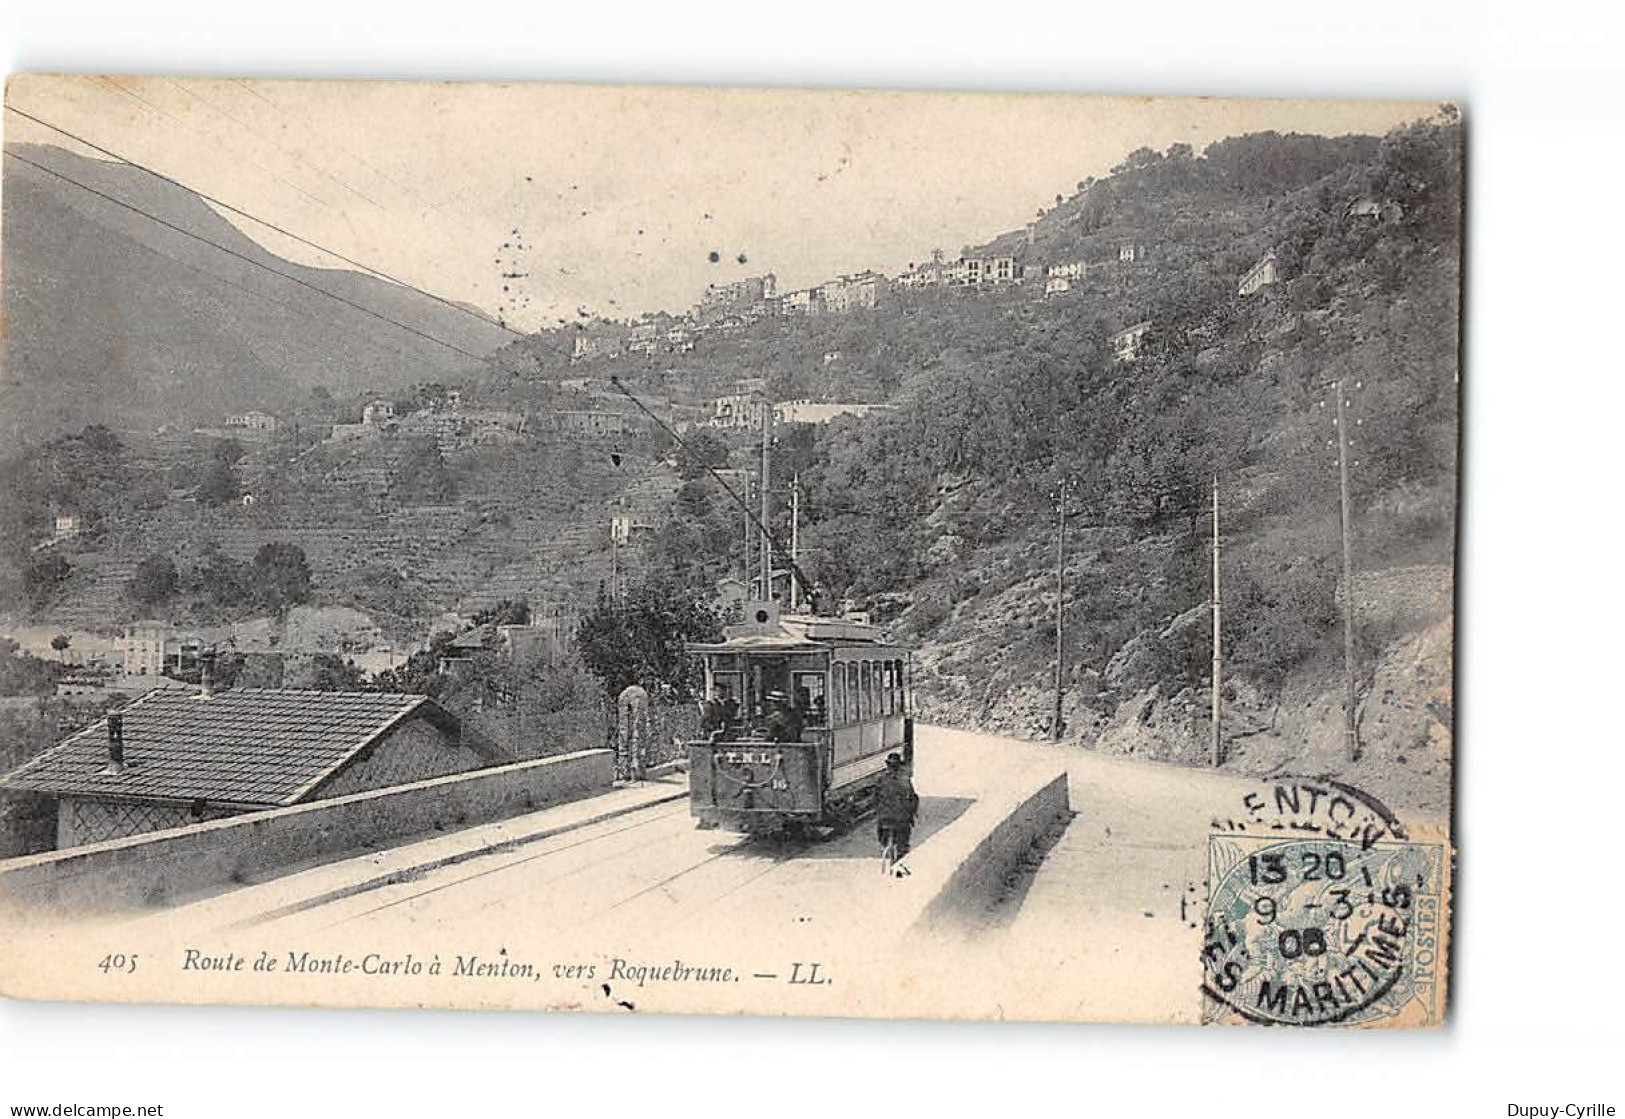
[917,567,1454,812]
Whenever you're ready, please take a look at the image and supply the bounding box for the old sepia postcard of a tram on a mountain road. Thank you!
[0,75,1464,1028]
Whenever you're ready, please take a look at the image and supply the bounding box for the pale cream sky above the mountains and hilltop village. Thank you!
[5,76,1437,330]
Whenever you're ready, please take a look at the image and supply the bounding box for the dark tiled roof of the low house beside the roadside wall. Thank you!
[0,689,457,807]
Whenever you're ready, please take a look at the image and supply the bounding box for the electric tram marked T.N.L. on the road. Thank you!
[687,603,913,833]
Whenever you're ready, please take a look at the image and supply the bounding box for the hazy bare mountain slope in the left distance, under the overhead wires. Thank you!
[0,145,509,445]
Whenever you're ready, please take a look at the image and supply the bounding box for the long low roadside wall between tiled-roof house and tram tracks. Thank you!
[0,750,614,914]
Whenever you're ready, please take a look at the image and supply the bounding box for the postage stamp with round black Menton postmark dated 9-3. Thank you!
[1201,781,1448,1026]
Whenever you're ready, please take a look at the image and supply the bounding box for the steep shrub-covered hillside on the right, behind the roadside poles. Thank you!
[668,110,1461,806]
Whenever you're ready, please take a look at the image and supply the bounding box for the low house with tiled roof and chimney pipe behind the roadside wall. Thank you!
[0,689,484,848]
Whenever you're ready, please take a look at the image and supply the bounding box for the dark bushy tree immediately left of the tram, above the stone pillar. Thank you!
[575,580,722,698]
